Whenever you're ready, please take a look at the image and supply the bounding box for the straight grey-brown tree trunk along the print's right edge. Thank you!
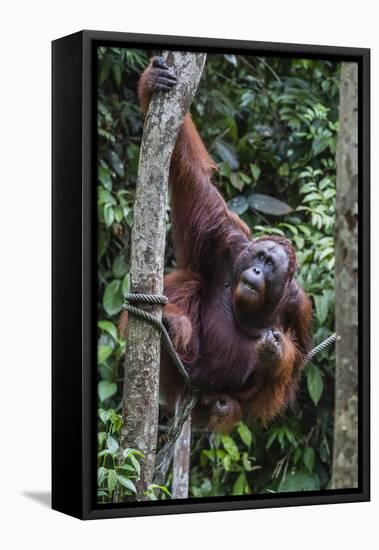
[332,63,358,489]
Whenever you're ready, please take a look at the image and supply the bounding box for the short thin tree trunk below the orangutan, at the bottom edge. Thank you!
[171,397,191,498]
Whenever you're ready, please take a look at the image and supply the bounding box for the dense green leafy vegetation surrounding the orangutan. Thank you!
[98,48,339,502]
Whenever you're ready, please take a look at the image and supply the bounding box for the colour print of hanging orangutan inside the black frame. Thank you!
[94,46,359,506]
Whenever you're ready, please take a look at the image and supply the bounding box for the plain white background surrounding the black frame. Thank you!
[0,0,379,550]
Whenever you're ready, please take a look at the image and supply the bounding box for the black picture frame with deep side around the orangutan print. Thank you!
[52,31,370,519]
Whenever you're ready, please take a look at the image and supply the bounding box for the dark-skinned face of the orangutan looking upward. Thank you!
[234,240,289,329]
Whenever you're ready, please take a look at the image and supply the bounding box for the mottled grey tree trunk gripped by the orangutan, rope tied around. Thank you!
[121,52,206,500]
